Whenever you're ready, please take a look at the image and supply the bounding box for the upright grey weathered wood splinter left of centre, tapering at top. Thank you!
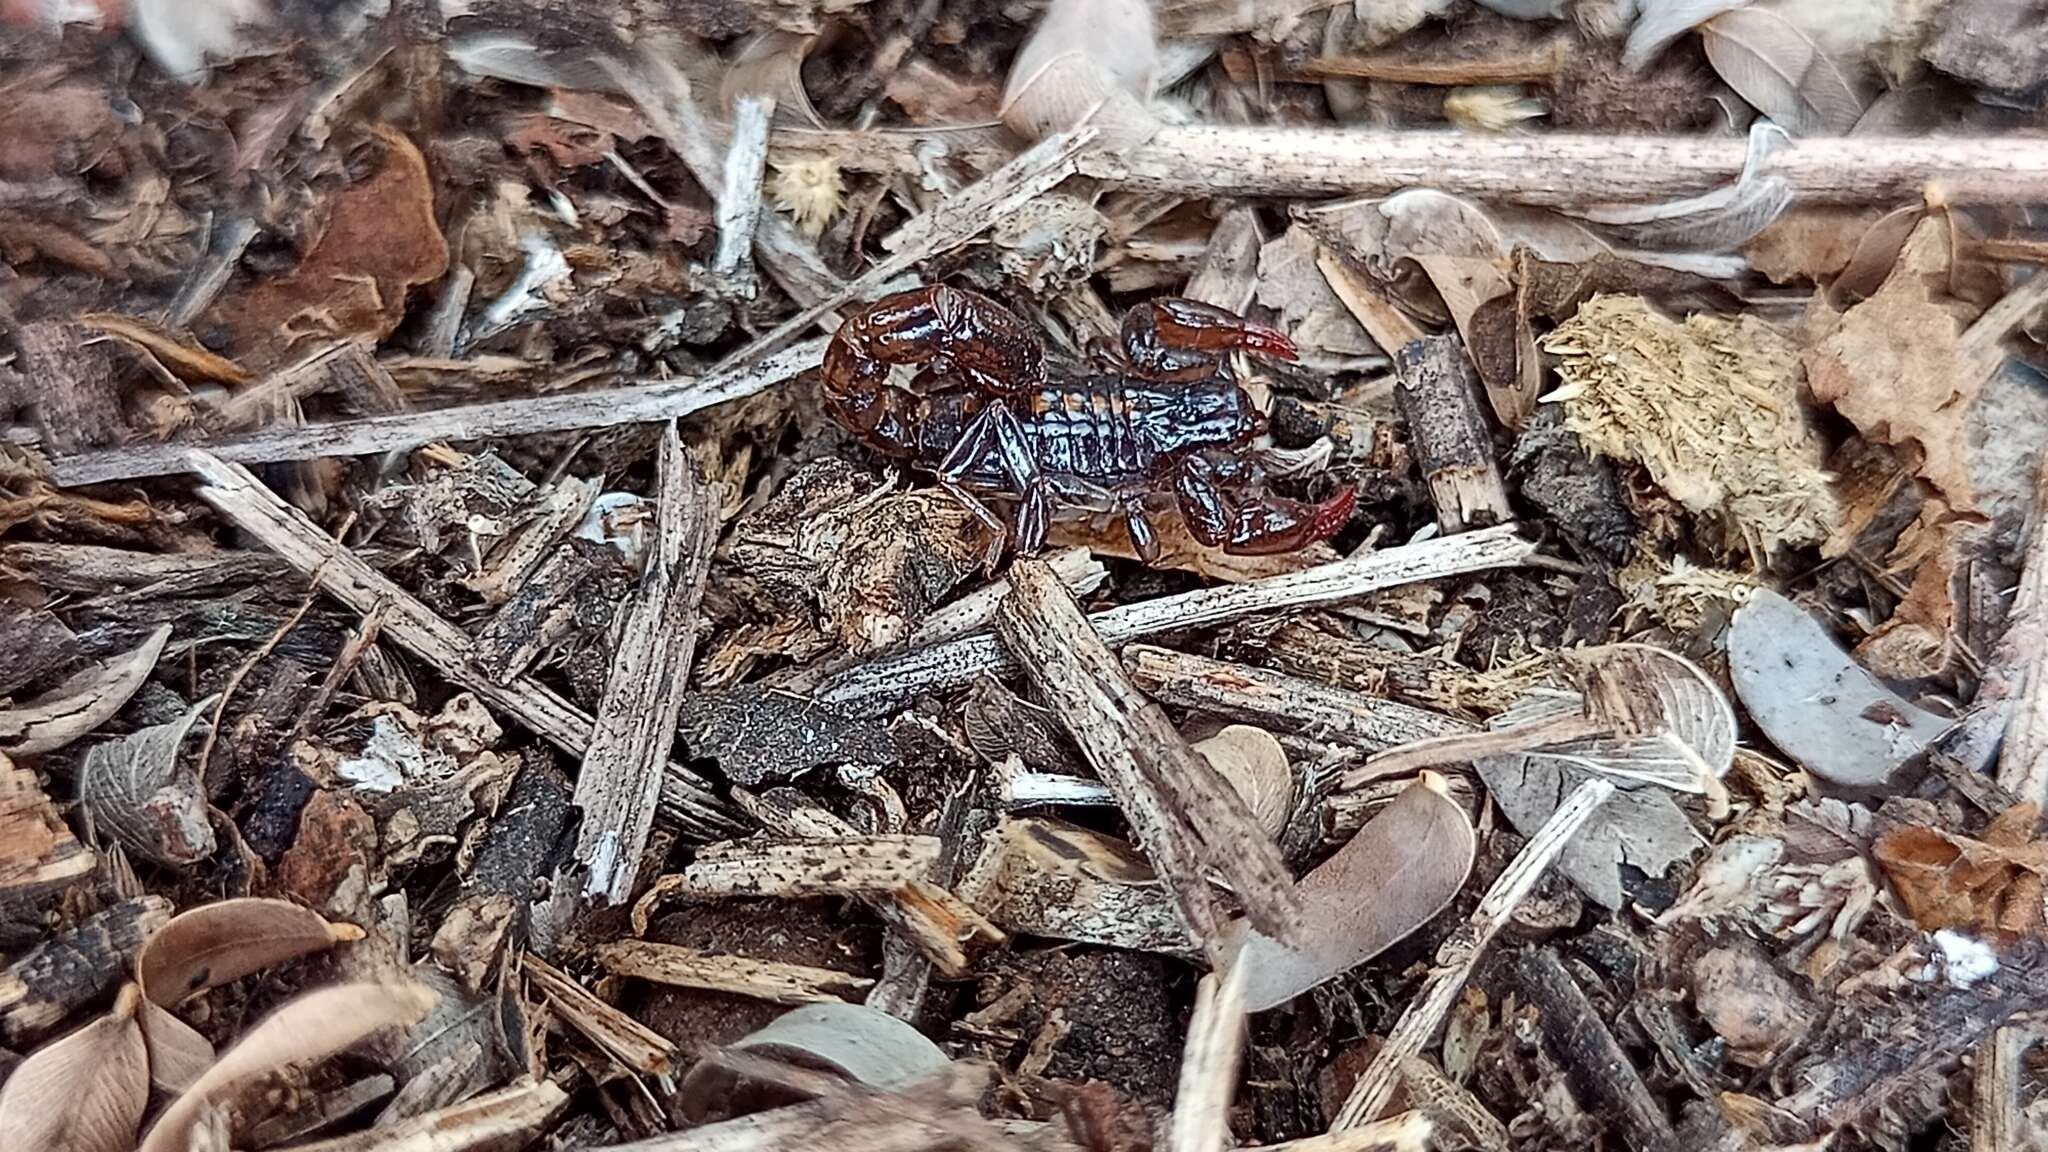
[575,422,719,904]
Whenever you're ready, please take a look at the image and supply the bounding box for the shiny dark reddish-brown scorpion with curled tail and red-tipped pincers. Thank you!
[823,285,1354,562]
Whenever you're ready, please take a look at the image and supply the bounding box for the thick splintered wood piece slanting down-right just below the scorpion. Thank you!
[995,560,1300,949]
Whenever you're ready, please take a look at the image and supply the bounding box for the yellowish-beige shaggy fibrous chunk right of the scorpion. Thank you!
[1542,297,1839,553]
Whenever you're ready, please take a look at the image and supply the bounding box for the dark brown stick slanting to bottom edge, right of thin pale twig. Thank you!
[1516,947,1681,1152]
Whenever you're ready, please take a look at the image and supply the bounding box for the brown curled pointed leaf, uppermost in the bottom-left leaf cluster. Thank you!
[135,896,362,1009]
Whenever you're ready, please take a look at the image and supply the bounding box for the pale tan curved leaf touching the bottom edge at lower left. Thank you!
[137,984,434,1152]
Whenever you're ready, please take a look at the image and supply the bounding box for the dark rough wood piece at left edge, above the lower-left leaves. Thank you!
[0,896,170,1043]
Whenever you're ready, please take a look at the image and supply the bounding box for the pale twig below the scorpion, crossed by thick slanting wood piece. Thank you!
[817,525,1536,711]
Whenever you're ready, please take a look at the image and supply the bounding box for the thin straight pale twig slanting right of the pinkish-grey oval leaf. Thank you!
[1329,777,1614,1132]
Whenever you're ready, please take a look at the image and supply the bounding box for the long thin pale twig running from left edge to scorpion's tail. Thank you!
[49,338,825,488]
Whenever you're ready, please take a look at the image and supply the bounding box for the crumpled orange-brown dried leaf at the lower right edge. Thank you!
[1874,804,2048,935]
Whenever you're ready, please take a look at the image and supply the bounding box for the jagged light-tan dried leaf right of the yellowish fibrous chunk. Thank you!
[1806,217,1989,510]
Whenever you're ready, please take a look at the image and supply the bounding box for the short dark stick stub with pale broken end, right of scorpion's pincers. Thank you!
[1395,336,1513,533]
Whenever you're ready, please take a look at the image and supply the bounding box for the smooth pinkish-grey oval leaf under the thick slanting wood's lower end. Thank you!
[1229,773,1477,1013]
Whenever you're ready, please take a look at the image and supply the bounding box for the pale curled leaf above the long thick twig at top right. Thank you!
[1700,8,1864,135]
